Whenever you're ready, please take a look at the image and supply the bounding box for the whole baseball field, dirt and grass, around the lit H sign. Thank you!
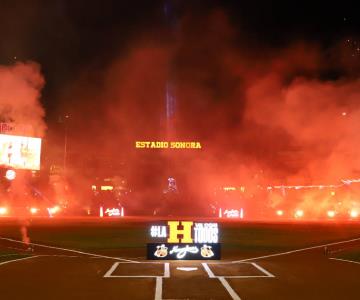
[0,217,360,300]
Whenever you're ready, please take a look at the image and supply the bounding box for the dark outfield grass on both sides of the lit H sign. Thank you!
[0,219,360,253]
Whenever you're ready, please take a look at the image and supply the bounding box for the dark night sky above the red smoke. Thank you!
[0,0,360,116]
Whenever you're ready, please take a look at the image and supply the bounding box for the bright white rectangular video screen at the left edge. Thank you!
[0,134,41,170]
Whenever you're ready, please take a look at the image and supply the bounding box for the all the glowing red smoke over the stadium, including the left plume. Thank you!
[0,5,360,219]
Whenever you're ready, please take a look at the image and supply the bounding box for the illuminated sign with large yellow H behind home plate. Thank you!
[147,221,220,260]
